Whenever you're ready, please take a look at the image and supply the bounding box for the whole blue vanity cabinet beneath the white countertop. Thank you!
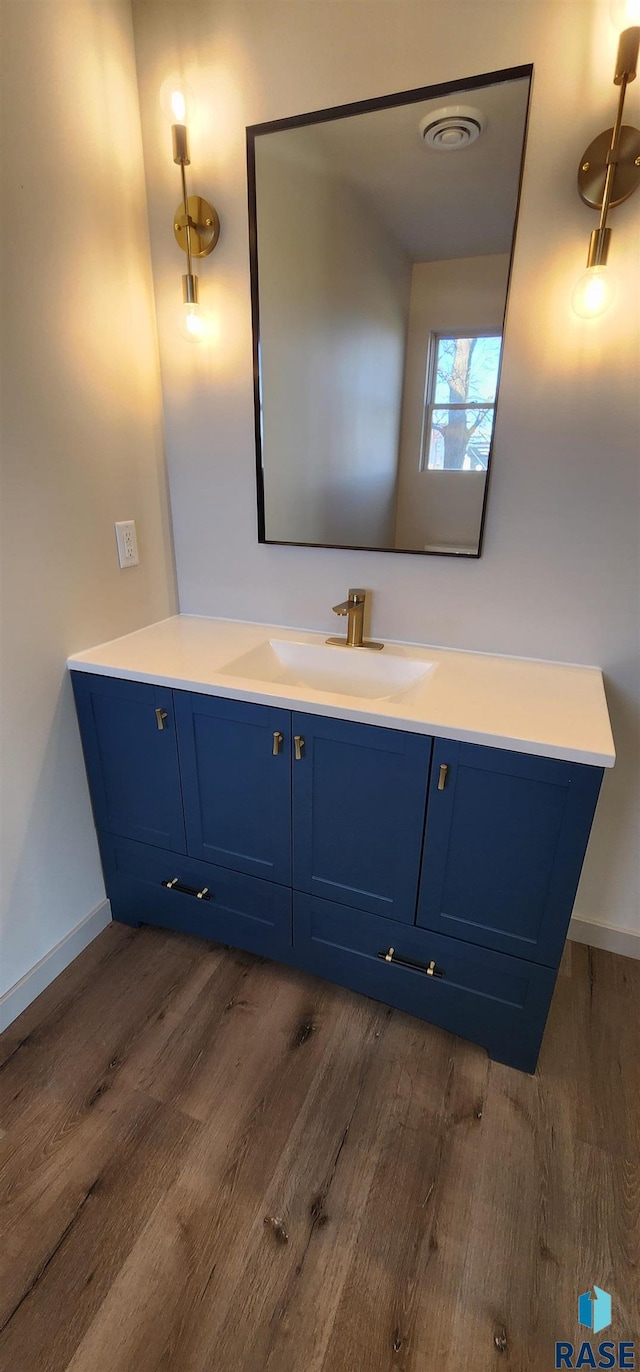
[73,672,603,1072]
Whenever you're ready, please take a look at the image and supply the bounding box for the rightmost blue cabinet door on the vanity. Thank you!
[418,740,602,966]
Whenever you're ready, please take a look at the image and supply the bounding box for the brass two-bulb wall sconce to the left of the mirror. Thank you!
[161,84,220,342]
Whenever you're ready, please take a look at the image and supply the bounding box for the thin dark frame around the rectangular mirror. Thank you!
[246,63,533,561]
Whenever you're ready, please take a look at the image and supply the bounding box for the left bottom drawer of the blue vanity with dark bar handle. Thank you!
[100,834,291,958]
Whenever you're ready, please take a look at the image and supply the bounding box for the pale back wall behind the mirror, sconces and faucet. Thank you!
[131,0,640,930]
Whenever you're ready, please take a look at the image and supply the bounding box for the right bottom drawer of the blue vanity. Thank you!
[294,893,555,1072]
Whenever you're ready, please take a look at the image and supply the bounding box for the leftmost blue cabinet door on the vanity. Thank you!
[71,672,185,853]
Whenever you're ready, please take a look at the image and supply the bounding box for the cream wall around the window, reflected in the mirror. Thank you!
[396,252,510,552]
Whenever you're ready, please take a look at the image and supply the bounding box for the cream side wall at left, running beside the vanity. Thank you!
[0,0,174,1018]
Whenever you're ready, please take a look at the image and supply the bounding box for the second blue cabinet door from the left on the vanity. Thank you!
[176,691,291,885]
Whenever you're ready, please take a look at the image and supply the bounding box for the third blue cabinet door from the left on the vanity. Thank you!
[293,715,431,923]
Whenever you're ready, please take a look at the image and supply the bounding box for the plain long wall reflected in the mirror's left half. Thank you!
[255,137,411,547]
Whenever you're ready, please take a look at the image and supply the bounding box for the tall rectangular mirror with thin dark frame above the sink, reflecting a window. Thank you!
[247,66,533,557]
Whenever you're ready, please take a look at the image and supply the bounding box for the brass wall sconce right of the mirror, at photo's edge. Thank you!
[571,27,640,320]
